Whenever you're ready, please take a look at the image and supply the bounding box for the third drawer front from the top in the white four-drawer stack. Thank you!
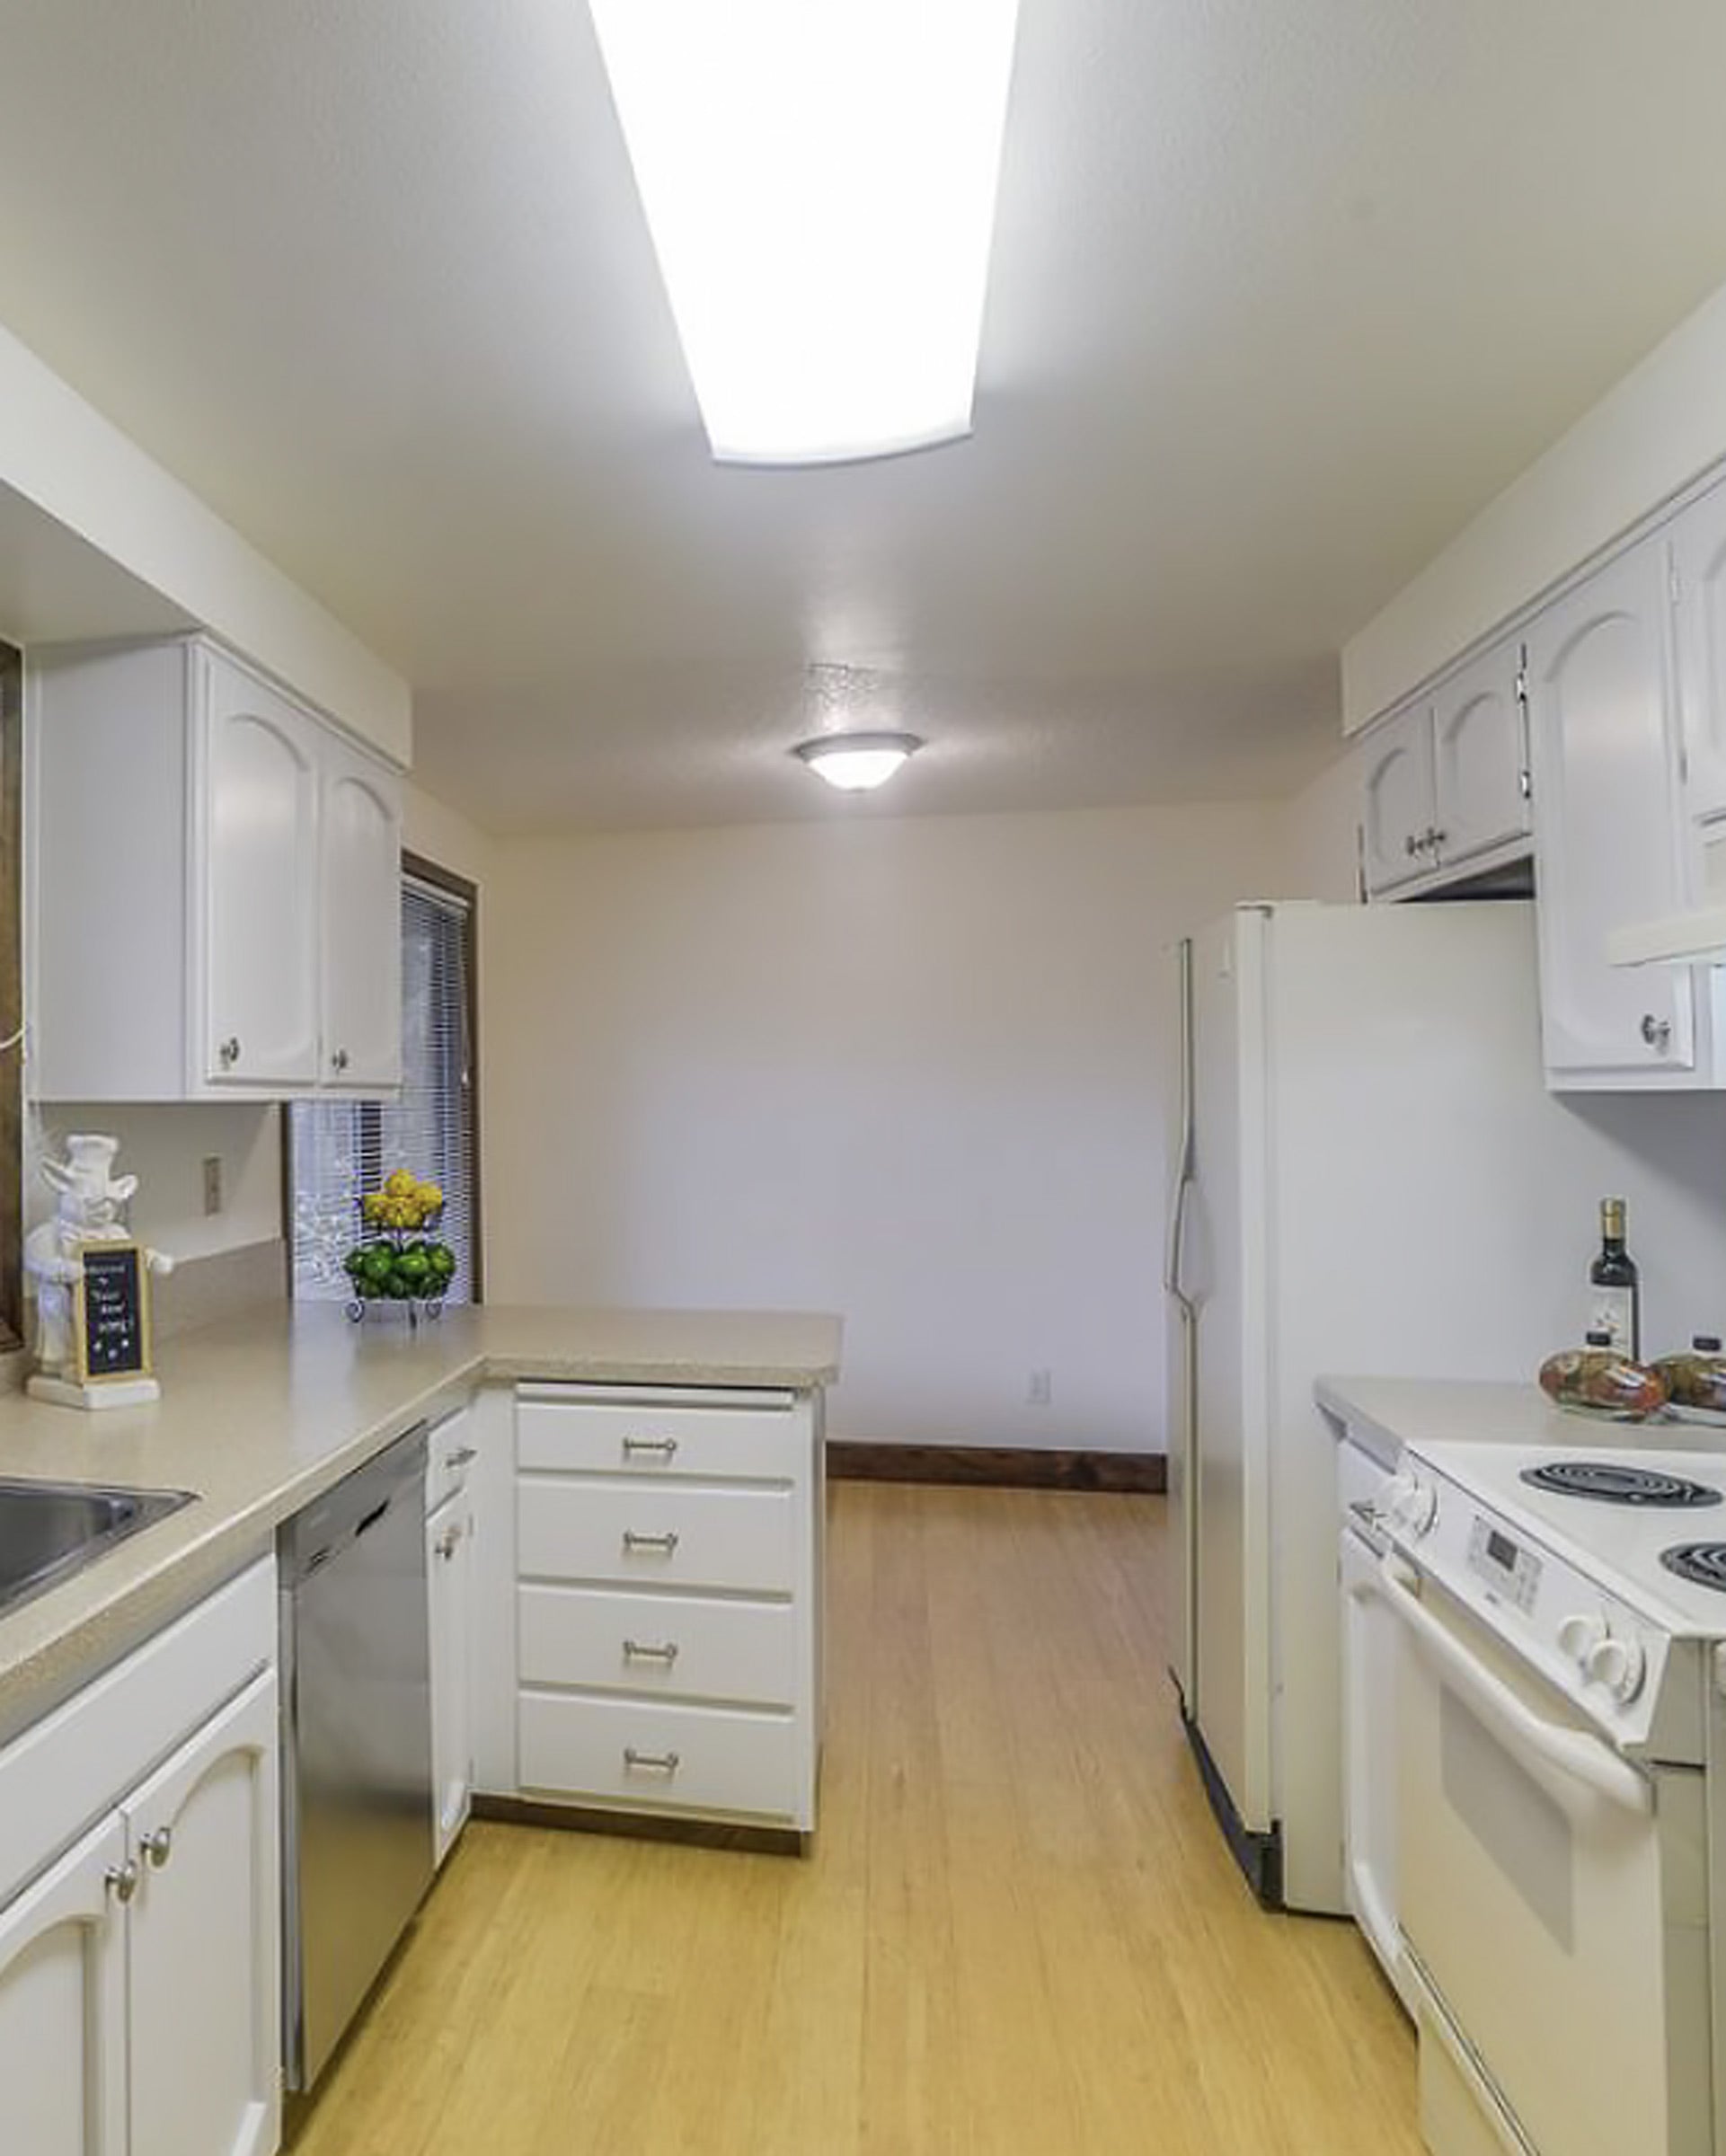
[516,1586,798,1708]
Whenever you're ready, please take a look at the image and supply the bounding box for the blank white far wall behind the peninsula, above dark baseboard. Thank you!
[481,808,1284,1449]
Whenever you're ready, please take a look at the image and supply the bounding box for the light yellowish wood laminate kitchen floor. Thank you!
[296,1483,1420,2156]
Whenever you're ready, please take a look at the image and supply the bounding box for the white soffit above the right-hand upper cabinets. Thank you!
[1342,287,1726,731]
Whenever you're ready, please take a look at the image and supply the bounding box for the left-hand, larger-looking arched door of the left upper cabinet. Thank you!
[194,651,322,1089]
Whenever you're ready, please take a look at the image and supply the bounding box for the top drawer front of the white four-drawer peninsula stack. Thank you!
[516,1392,809,1481]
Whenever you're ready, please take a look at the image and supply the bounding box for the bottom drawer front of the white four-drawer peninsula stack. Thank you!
[518,1692,802,1817]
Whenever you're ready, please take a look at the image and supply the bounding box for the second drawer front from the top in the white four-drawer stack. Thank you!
[516,1475,796,1594]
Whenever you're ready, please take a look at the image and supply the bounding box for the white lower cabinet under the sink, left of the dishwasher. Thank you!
[0,1561,280,2156]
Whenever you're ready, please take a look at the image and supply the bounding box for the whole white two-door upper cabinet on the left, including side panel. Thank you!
[28,638,402,1101]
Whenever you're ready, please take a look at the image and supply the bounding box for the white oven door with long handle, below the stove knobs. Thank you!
[1381,1557,1713,2156]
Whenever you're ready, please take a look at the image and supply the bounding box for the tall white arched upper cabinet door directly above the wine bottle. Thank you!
[1526,535,1717,1091]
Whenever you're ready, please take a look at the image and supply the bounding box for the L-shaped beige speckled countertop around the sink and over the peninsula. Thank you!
[0,1304,841,1737]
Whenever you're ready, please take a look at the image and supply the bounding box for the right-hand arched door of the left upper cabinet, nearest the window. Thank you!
[319,742,402,1091]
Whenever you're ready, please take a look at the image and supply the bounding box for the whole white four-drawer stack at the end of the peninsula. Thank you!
[516,1384,822,1833]
